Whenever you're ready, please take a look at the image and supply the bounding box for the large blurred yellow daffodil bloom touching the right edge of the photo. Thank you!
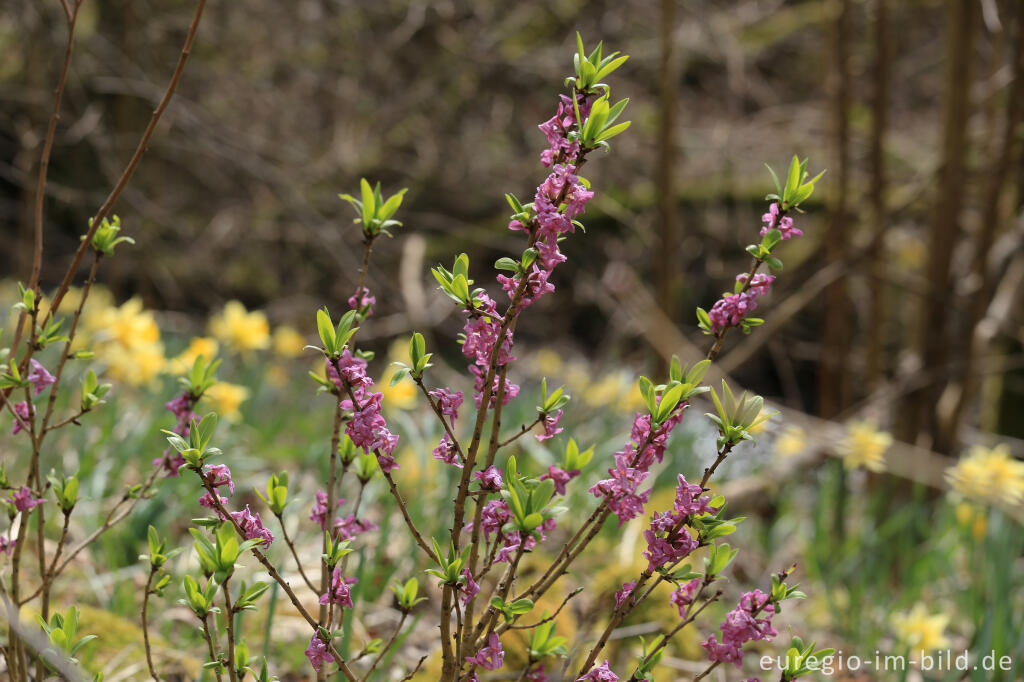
[946,443,1024,507]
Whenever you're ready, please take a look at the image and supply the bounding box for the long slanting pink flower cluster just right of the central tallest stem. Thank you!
[590,402,686,525]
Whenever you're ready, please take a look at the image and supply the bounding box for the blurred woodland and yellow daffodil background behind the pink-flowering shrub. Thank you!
[0,0,1024,680]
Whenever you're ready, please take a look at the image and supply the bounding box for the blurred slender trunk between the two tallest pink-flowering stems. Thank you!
[654,0,679,374]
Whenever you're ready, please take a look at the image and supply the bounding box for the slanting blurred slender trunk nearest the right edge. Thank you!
[939,2,1024,446]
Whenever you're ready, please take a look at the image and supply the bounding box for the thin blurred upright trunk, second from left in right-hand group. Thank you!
[865,0,892,390]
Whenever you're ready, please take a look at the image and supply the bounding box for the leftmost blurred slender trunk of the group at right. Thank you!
[818,0,851,419]
